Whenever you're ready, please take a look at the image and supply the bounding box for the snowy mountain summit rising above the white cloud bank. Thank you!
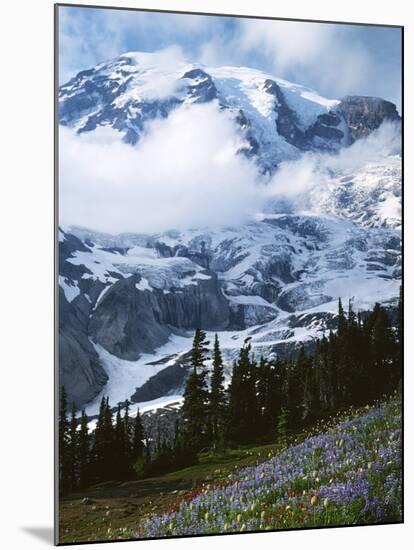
[59,52,399,171]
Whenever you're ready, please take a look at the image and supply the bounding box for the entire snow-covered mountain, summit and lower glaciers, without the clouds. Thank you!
[59,53,401,414]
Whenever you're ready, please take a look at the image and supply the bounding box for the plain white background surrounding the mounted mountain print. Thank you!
[0,0,414,550]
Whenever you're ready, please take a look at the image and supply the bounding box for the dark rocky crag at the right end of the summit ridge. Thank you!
[339,96,401,143]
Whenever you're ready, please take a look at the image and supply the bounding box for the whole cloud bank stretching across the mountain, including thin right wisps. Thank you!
[59,98,401,233]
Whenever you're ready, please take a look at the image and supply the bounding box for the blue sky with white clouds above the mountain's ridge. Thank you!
[59,6,401,110]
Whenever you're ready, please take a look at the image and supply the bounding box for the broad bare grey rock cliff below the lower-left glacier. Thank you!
[89,272,229,360]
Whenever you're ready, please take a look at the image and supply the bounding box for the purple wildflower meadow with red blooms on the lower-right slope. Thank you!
[134,401,402,538]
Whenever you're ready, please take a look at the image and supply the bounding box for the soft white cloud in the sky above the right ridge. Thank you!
[239,20,398,103]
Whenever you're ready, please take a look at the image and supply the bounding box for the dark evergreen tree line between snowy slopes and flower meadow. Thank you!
[59,295,403,492]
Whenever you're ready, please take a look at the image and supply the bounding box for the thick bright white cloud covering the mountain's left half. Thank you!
[59,104,263,233]
